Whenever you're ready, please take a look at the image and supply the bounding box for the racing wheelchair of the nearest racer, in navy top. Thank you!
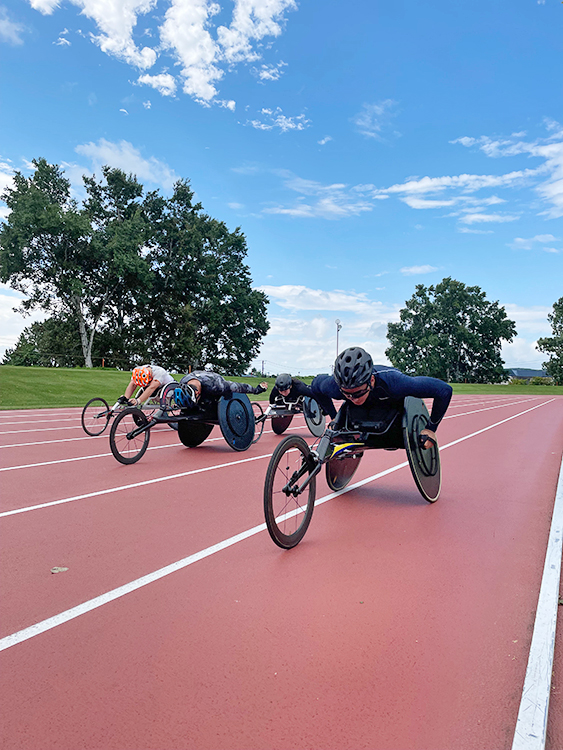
[264,396,441,549]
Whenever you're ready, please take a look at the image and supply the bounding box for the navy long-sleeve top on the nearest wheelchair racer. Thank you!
[311,365,453,432]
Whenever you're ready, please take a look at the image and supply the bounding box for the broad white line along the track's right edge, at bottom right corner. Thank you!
[512,452,563,750]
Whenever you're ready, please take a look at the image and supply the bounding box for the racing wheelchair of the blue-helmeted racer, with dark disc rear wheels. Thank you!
[109,383,263,464]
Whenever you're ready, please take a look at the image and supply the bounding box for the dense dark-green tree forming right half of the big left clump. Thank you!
[145,180,269,375]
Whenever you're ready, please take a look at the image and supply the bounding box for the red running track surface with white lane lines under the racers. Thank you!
[0,395,563,750]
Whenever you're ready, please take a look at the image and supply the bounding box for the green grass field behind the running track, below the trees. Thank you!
[0,365,563,409]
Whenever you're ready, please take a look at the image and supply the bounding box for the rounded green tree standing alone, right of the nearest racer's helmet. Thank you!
[385,277,516,383]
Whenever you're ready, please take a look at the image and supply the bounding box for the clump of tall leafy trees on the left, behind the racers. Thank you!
[0,159,269,375]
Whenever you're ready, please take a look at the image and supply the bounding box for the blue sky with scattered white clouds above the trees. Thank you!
[0,0,563,374]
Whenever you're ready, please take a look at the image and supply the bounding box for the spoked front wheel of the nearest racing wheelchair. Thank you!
[264,435,316,549]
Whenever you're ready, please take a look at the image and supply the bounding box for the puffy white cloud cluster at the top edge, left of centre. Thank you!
[27,0,297,109]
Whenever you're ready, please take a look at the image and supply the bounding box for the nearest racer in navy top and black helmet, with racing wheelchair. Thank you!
[264,347,452,549]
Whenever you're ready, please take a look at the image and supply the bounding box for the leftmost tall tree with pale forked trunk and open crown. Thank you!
[0,159,149,367]
